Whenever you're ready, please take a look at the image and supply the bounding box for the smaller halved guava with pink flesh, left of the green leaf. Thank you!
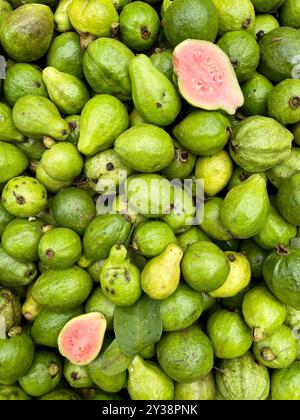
[57,312,106,366]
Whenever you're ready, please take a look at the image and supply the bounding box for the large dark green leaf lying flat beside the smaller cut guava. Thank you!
[114,296,163,357]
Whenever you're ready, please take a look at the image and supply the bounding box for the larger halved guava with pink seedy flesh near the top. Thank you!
[173,39,244,115]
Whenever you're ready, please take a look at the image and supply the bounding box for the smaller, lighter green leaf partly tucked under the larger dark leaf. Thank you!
[98,340,131,376]
